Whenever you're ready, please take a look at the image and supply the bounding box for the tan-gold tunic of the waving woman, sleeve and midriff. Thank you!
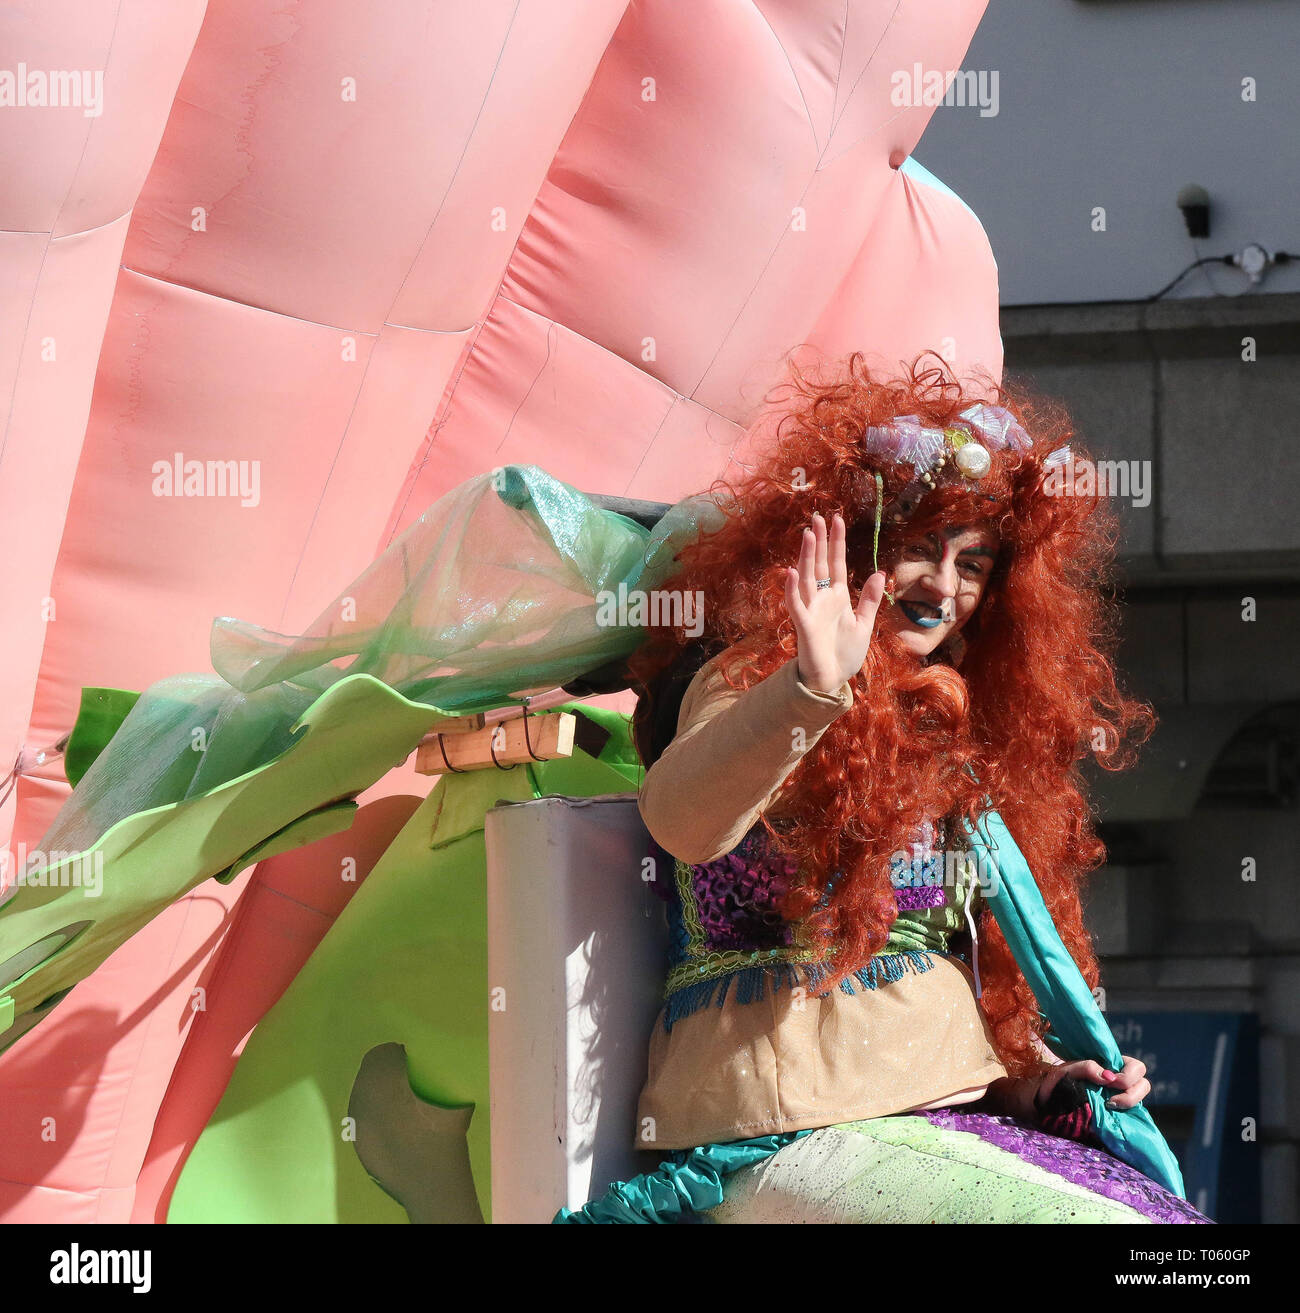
[636,653,1007,1150]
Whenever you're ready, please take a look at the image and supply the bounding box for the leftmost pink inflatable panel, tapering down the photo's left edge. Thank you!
[0,0,205,843]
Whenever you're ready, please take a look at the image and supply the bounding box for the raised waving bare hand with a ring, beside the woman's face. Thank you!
[785,511,885,693]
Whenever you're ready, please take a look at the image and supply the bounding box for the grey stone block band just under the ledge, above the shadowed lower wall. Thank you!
[1002,294,1300,588]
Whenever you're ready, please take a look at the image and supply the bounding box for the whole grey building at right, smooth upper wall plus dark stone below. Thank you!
[892,0,1300,1222]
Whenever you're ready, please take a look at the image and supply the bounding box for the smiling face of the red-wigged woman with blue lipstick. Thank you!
[880,525,998,657]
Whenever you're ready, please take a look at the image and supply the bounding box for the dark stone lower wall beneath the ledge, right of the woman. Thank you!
[1002,295,1300,1222]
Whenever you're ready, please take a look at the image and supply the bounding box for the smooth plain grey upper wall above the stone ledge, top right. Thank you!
[915,0,1300,305]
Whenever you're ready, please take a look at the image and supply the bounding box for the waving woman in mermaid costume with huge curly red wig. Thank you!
[557,355,1207,1222]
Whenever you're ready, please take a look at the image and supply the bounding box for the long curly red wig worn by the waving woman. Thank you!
[629,353,1154,1074]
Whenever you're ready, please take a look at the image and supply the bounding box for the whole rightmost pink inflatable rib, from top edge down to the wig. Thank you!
[389,0,1001,522]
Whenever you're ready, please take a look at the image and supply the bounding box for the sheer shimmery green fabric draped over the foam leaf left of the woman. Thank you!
[41,465,722,852]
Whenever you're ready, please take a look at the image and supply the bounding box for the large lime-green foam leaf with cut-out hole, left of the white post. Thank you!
[167,705,639,1225]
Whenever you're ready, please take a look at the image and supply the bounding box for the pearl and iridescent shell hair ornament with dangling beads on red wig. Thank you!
[863,402,1070,601]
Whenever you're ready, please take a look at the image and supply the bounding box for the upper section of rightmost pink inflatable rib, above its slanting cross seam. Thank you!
[502,0,987,414]
